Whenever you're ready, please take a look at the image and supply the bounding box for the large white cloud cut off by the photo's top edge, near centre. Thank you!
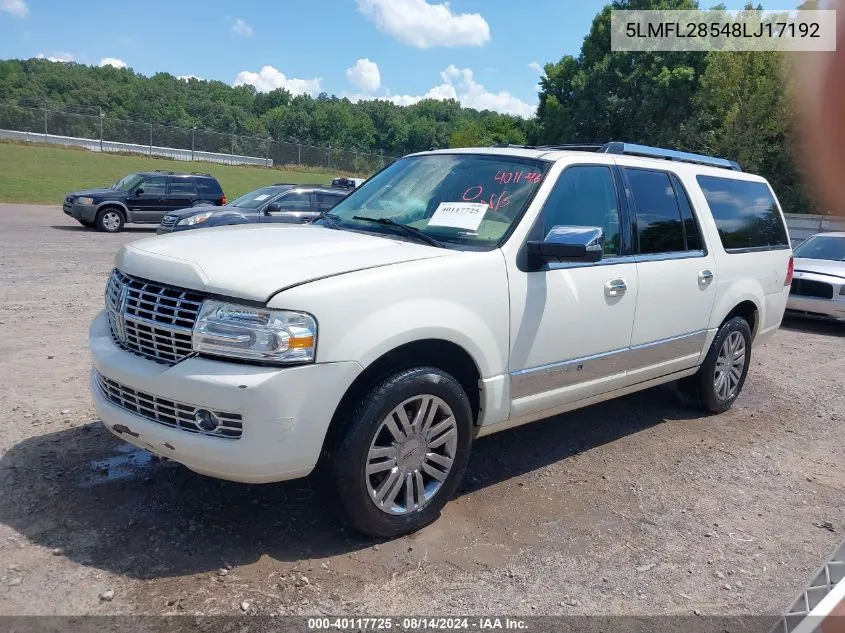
[358,0,490,48]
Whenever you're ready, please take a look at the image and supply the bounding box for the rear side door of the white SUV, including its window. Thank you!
[621,166,718,384]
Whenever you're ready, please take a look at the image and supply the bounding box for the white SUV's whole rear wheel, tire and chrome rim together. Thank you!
[678,317,751,413]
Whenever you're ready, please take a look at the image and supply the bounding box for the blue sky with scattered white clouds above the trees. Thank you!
[0,0,797,115]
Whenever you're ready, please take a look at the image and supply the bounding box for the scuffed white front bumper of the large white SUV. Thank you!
[89,313,361,483]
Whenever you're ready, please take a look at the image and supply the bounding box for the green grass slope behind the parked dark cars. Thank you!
[0,143,331,204]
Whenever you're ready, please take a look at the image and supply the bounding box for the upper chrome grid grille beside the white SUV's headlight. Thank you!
[106,269,205,365]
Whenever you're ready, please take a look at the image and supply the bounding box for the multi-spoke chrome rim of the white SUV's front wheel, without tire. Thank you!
[364,395,458,515]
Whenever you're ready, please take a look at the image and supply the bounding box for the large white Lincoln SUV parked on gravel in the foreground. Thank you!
[90,143,792,536]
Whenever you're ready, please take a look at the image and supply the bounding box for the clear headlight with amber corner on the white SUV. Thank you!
[193,299,317,363]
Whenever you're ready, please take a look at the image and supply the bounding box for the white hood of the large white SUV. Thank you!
[115,224,456,302]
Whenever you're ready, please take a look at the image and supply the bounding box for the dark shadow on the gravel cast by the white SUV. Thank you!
[0,380,698,579]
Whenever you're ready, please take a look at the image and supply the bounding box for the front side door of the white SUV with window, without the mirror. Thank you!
[508,165,639,418]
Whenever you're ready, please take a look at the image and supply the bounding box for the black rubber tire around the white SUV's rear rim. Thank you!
[677,317,751,413]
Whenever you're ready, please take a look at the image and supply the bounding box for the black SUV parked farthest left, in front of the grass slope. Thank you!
[62,171,226,233]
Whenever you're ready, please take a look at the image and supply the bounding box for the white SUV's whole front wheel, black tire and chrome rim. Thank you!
[330,367,472,538]
